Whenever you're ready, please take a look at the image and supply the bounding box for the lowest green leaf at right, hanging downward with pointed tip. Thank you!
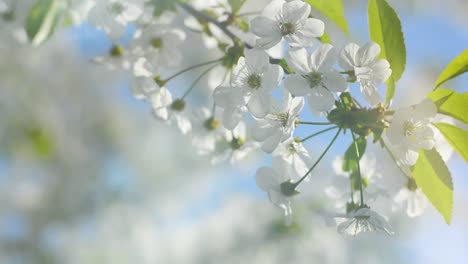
[413,149,453,224]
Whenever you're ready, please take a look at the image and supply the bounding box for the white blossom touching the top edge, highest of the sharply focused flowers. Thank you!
[251,0,325,48]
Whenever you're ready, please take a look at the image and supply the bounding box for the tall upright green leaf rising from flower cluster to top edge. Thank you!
[368,0,406,103]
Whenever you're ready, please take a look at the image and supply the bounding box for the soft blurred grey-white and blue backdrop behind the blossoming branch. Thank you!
[0,0,468,264]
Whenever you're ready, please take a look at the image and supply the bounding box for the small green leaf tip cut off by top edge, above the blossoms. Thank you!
[306,0,349,34]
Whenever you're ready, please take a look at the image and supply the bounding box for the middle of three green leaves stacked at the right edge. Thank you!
[428,89,468,124]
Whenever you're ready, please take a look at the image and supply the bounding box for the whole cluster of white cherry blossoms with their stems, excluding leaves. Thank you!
[6,0,446,235]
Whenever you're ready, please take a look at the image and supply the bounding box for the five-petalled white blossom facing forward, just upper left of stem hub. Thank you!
[284,44,347,112]
